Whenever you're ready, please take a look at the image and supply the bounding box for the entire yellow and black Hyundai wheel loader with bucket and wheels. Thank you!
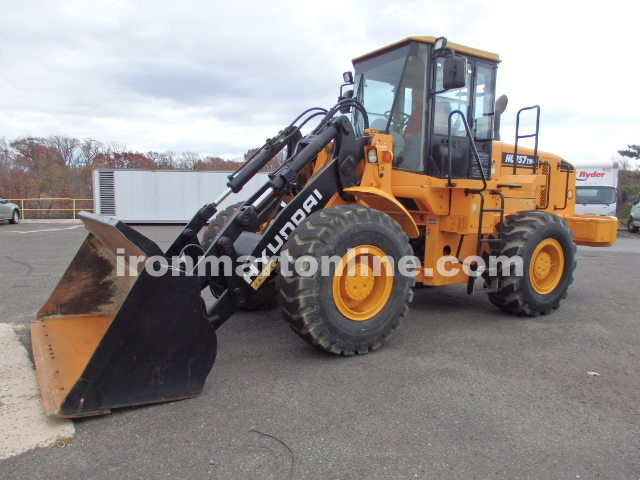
[31,37,617,417]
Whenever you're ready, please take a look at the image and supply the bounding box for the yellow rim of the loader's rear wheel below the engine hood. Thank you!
[529,238,564,295]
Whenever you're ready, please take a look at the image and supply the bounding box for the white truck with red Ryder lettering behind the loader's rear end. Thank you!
[576,163,618,217]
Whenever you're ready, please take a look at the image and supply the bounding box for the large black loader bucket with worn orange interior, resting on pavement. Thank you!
[31,212,217,417]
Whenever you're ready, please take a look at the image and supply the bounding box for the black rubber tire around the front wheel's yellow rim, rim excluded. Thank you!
[276,205,415,356]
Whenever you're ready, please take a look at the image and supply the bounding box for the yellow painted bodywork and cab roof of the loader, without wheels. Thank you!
[321,47,617,285]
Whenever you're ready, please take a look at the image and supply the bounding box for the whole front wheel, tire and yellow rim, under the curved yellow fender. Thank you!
[276,205,415,355]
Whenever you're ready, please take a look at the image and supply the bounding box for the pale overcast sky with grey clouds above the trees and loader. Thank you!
[0,0,640,164]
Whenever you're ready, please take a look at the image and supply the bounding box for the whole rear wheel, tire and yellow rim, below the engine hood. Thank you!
[485,212,576,317]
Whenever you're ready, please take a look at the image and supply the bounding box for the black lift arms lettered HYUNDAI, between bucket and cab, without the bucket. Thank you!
[166,99,369,328]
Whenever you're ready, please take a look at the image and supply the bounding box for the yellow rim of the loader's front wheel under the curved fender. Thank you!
[333,245,393,322]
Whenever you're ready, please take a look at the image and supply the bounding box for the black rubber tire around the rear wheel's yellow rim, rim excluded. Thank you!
[485,212,577,317]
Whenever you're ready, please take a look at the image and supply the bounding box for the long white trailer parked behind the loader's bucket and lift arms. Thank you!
[93,168,267,223]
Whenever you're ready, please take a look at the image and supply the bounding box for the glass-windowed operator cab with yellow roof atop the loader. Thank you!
[353,37,499,179]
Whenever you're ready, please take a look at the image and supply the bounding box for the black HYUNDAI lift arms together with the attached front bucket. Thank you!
[31,99,369,417]
